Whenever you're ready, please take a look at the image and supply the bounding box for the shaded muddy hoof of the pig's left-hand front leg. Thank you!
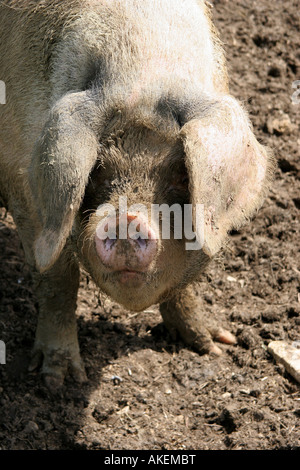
[29,349,87,392]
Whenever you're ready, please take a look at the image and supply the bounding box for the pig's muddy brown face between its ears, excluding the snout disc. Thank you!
[76,124,206,311]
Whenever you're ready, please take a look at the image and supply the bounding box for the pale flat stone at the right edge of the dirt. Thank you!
[268,341,300,383]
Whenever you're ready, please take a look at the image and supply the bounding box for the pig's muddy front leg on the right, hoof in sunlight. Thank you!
[160,286,236,355]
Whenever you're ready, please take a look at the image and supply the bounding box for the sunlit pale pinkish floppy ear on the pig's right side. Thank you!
[180,96,274,257]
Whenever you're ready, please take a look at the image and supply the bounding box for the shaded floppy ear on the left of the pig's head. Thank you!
[29,92,97,272]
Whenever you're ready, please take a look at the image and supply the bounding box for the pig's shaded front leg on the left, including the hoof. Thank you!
[29,251,86,389]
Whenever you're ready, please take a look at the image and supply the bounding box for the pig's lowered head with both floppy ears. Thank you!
[30,92,272,310]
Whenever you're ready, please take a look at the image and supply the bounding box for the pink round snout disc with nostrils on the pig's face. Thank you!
[95,213,158,273]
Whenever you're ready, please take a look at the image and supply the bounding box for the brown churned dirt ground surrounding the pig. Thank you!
[0,0,300,450]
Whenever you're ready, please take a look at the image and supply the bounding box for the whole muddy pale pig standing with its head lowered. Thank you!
[0,0,273,387]
